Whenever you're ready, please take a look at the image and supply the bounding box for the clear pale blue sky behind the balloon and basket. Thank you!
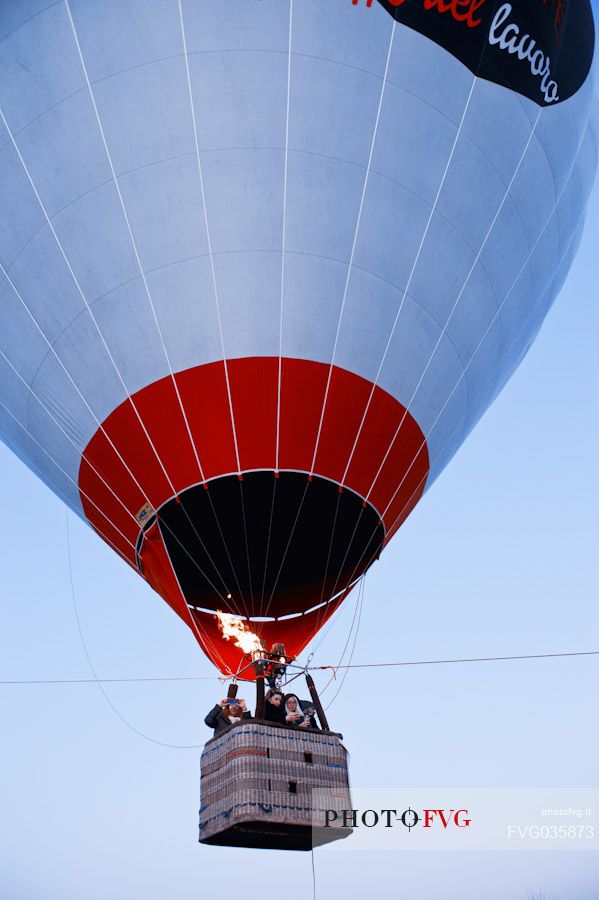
[0,26,599,900]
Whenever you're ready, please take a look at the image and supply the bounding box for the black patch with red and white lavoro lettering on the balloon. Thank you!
[378,0,595,106]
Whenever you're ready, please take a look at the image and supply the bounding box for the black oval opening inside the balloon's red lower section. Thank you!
[150,471,384,617]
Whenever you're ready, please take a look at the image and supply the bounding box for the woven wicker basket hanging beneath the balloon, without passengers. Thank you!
[200,720,351,850]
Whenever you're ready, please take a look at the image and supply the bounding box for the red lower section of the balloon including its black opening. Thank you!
[79,358,428,672]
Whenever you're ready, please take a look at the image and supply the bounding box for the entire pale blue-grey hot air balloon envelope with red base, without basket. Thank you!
[0,0,596,678]
